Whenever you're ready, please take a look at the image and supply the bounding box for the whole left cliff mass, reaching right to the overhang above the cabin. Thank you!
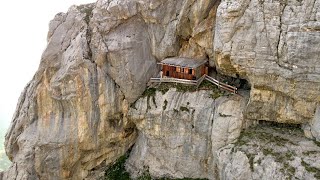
[1,0,222,179]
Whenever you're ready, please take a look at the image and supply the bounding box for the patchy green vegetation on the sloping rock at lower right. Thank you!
[231,123,320,179]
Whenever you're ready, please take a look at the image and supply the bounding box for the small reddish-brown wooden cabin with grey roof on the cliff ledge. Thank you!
[159,57,208,80]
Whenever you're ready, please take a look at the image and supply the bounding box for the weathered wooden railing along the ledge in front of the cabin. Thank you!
[149,75,238,94]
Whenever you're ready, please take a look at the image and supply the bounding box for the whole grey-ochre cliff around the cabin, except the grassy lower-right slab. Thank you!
[0,0,320,179]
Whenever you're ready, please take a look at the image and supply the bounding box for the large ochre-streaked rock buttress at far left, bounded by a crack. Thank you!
[4,5,137,179]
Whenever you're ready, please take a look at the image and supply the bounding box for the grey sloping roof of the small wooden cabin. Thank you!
[160,57,208,68]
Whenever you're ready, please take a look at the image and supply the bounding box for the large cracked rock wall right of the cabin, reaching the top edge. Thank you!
[214,0,320,123]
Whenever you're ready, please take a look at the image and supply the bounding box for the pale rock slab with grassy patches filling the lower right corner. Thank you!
[216,125,320,180]
